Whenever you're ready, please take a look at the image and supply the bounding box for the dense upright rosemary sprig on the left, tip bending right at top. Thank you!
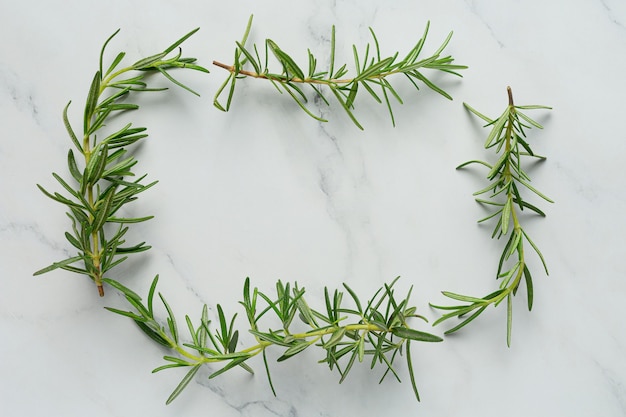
[34,29,208,296]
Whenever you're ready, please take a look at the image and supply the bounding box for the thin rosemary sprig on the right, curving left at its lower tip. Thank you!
[431,87,553,346]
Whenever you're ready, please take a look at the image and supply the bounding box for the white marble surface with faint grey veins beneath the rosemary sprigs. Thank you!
[0,0,626,417]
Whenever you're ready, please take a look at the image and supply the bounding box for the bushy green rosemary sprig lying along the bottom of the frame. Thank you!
[104,276,442,404]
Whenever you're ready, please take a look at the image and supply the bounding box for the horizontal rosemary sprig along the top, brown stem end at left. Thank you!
[213,16,467,129]
